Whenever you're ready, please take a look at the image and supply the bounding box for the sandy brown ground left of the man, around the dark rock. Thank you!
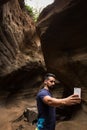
[0,97,35,130]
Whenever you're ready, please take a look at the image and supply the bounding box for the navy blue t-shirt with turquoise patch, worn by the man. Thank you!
[36,88,56,130]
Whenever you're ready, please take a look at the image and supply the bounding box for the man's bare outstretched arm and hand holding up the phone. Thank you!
[43,95,81,107]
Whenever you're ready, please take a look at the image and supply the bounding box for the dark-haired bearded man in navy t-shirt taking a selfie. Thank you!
[36,73,81,130]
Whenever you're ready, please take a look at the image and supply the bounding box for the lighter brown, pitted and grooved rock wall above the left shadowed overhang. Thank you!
[0,0,43,76]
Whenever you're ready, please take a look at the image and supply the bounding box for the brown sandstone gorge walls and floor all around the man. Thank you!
[0,0,87,130]
